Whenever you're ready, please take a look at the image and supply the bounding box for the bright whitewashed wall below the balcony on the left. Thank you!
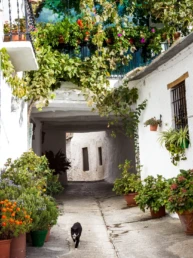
[0,78,27,168]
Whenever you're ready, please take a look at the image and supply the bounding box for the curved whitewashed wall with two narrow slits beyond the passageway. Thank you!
[66,132,135,182]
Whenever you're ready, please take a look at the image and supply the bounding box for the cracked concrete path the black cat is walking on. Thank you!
[27,182,193,258]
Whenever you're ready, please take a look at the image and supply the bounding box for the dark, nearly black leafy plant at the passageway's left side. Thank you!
[45,150,71,175]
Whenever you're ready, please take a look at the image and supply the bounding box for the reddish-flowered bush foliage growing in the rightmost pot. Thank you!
[166,169,193,213]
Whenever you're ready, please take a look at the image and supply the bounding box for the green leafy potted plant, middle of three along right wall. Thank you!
[135,175,166,218]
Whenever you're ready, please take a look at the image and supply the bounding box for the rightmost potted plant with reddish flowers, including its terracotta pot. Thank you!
[166,169,193,235]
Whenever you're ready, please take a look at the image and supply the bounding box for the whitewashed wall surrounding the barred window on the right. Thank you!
[129,44,193,178]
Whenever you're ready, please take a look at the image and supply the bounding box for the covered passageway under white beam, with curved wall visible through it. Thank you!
[31,81,135,184]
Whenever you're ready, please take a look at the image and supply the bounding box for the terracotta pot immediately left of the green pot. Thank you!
[10,234,26,258]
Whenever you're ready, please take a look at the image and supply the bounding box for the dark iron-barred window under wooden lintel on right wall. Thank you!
[171,81,188,129]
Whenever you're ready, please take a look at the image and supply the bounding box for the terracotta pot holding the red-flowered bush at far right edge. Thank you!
[177,211,193,235]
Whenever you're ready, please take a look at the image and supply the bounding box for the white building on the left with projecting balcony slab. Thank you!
[0,0,38,168]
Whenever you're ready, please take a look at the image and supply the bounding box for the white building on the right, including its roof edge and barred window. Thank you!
[129,34,193,178]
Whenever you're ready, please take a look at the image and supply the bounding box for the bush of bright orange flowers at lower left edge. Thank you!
[0,199,32,240]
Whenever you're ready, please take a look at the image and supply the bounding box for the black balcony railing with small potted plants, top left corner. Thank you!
[4,0,35,49]
